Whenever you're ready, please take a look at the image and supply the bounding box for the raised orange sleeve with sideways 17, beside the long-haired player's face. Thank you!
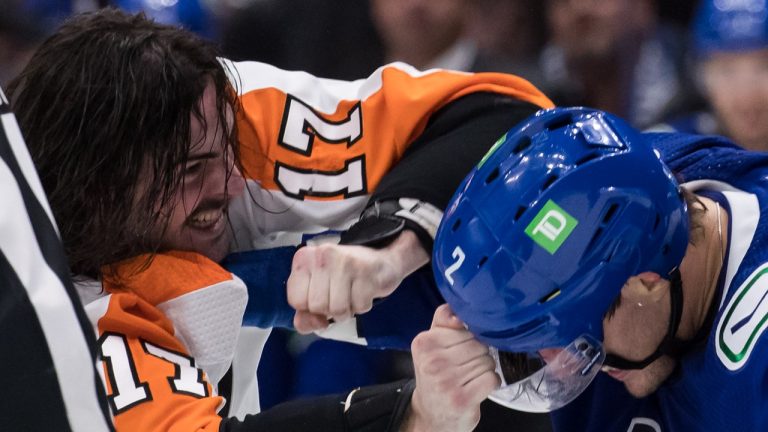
[238,64,553,200]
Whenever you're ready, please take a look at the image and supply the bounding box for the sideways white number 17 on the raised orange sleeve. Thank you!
[275,95,368,199]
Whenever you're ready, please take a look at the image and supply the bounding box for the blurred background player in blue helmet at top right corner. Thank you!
[666,0,768,151]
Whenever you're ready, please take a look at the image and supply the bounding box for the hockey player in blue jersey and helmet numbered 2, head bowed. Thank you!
[433,108,768,432]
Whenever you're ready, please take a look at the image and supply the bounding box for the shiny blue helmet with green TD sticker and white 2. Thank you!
[433,108,688,352]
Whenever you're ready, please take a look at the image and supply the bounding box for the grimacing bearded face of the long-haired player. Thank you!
[152,83,245,262]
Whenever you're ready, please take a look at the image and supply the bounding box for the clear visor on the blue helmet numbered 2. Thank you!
[489,335,605,413]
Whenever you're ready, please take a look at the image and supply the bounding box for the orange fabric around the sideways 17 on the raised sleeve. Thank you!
[238,66,554,199]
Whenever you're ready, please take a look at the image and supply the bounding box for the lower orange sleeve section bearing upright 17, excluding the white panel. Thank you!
[98,293,222,432]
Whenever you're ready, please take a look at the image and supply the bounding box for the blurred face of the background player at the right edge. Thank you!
[700,47,768,151]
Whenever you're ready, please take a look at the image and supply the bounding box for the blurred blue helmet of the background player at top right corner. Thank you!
[693,0,768,56]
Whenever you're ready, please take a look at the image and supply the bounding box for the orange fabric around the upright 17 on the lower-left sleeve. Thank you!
[98,252,232,432]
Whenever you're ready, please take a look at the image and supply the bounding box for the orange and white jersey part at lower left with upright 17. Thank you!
[76,252,248,432]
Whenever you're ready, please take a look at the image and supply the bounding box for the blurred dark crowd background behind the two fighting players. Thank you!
[0,0,768,418]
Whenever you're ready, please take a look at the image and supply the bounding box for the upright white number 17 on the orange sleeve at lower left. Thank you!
[99,333,213,414]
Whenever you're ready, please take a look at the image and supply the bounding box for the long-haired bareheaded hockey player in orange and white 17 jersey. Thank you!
[12,10,551,431]
